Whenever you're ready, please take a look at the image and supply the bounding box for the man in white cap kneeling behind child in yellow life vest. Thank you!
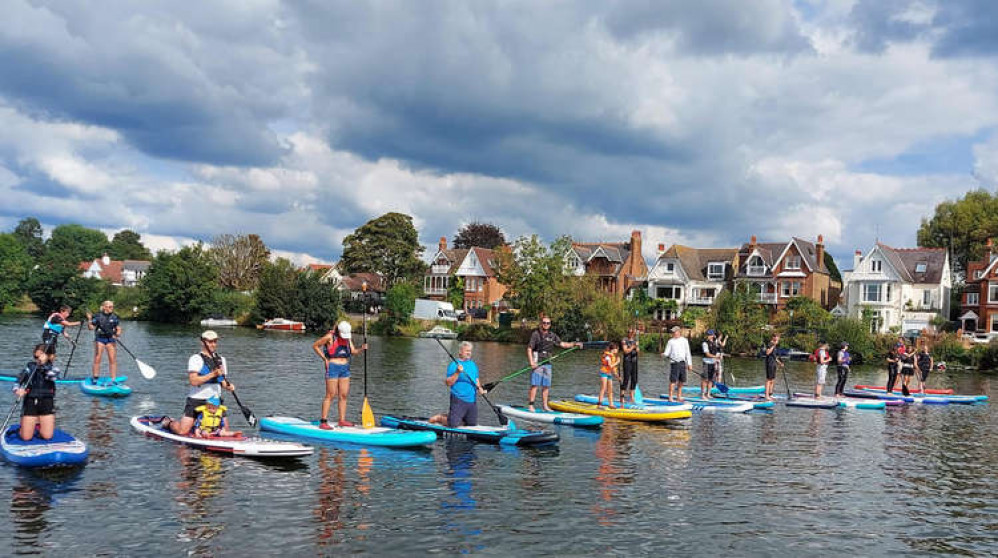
[163,329,236,436]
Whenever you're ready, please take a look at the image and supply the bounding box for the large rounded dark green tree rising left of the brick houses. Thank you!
[340,213,426,285]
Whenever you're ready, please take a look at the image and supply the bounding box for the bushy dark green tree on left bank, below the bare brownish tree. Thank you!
[141,244,219,323]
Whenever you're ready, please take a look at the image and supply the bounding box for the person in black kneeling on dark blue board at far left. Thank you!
[14,343,59,441]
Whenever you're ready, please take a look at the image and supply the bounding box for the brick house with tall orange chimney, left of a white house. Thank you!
[567,231,648,297]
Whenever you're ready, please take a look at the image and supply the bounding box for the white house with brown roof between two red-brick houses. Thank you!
[648,244,738,319]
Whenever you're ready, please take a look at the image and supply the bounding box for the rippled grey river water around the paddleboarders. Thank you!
[0,317,998,556]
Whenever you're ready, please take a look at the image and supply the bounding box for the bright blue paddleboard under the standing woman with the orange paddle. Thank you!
[260,417,437,448]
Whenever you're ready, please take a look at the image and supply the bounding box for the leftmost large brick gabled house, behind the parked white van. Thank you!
[423,237,507,312]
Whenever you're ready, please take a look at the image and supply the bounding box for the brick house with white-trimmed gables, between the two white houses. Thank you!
[734,235,840,312]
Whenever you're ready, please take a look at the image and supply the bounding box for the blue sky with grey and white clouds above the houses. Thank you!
[0,0,998,267]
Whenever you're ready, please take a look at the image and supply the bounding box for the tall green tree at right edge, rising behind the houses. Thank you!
[918,190,998,273]
